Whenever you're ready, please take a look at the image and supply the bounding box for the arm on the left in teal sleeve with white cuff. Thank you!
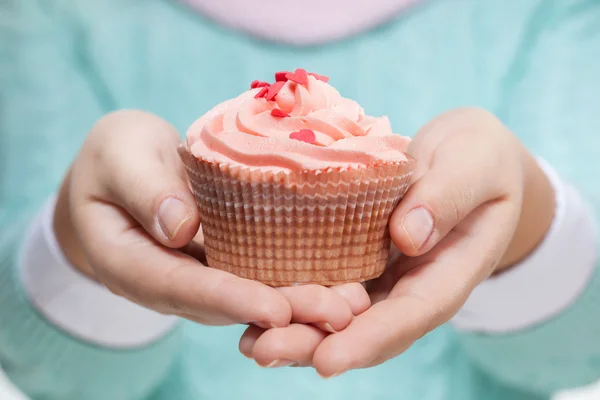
[0,0,178,400]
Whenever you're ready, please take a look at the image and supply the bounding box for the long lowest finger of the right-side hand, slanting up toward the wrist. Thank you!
[313,204,514,376]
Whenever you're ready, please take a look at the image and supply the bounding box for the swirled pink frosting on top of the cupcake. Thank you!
[187,76,410,171]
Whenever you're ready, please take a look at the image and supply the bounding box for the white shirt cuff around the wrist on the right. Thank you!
[451,160,598,334]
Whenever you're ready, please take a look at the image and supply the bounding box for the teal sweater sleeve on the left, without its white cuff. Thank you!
[0,0,179,400]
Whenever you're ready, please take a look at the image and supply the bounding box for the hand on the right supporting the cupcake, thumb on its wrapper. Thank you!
[240,109,554,377]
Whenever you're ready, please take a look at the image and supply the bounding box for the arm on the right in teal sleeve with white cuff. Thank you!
[454,2,600,393]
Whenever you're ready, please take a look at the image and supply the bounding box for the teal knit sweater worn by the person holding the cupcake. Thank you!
[0,0,600,400]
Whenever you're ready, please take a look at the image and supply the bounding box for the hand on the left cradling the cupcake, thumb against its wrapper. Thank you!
[54,111,369,330]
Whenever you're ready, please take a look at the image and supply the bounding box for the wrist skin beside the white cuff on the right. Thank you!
[496,150,556,273]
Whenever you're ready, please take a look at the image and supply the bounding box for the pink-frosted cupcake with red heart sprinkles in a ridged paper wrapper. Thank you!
[179,69,413,286]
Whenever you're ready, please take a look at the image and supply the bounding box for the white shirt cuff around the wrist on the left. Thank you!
[19,197,177,348]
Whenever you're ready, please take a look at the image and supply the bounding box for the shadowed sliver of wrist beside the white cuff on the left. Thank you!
[52,172,95,280]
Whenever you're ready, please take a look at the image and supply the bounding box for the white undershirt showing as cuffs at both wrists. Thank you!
[19,162,597,348]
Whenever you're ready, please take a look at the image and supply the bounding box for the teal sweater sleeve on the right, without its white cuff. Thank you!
[458,0,600,394]
